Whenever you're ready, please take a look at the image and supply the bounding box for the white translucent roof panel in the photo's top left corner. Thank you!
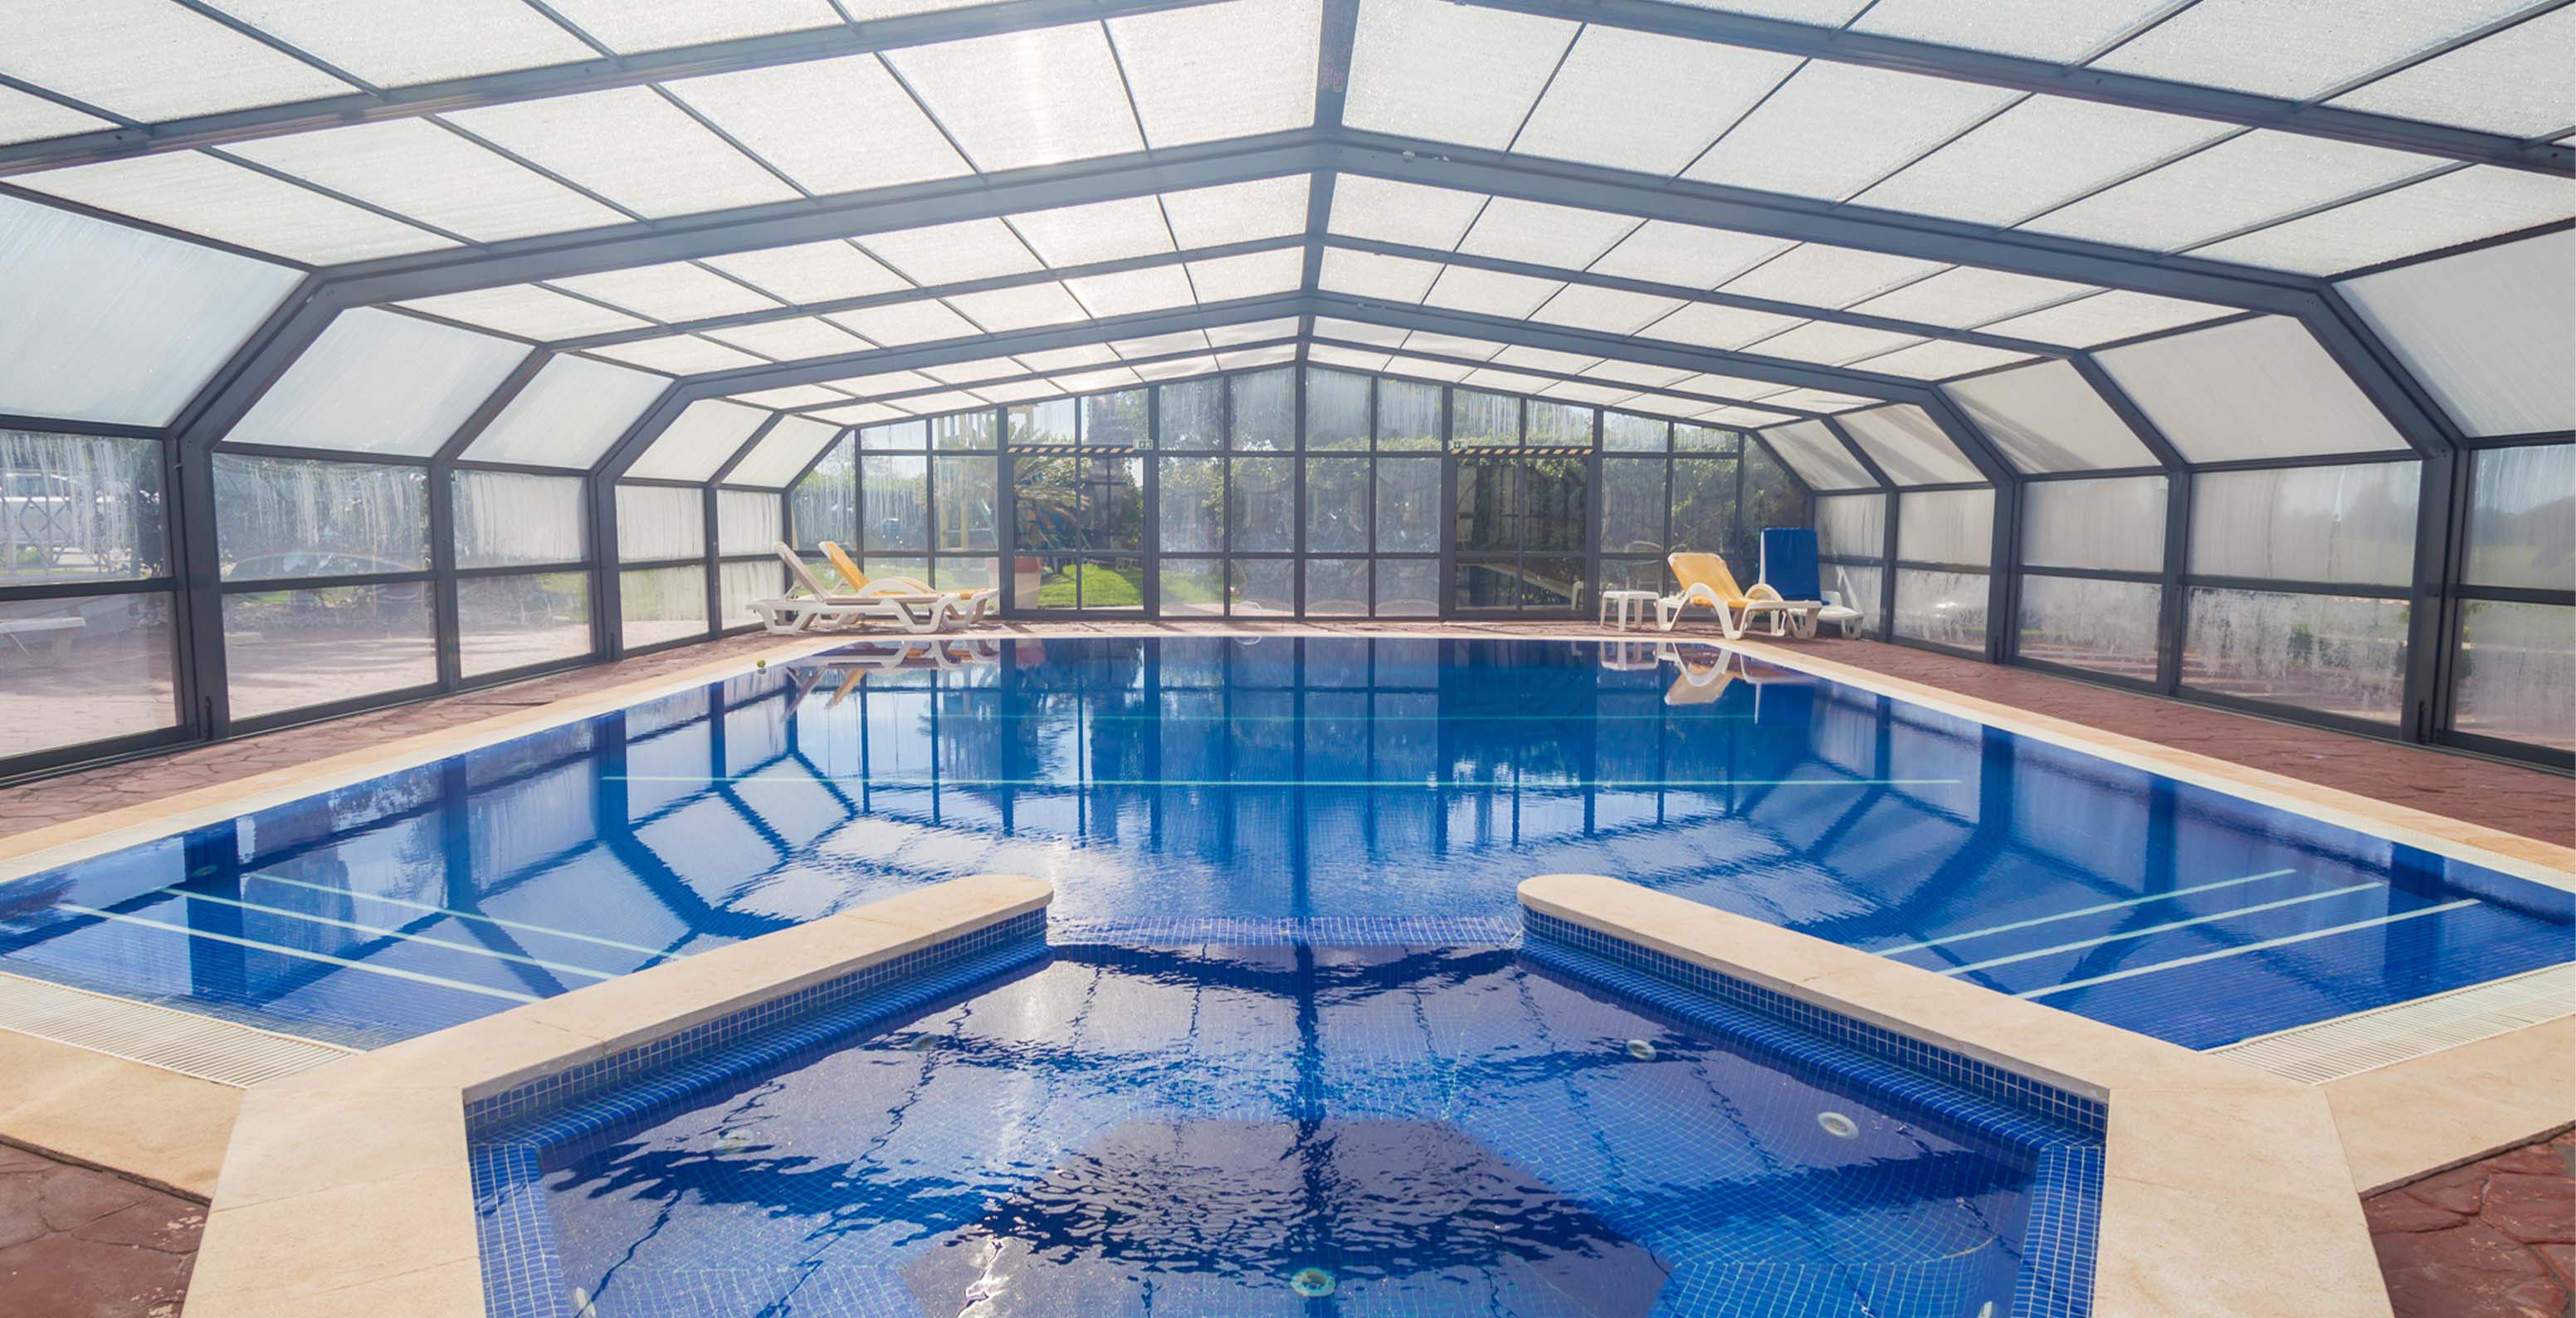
[0,0,358,121]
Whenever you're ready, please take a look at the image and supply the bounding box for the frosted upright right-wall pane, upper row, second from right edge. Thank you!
[2189,461,2422,587]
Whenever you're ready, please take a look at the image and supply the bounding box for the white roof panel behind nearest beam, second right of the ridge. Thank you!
[1512,26,1798,178]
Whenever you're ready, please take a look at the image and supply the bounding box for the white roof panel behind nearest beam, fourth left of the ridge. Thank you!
[443,87,798,219]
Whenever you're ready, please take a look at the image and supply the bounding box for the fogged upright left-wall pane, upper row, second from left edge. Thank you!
[214,453,430,582]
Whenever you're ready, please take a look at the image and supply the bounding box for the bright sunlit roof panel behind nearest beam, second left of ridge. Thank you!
[886,23,1144,173]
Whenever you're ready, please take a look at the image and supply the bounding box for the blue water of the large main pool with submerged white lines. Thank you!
[0,638,2576,1047]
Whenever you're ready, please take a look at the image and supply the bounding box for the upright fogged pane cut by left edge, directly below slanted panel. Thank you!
[0,430,170,587]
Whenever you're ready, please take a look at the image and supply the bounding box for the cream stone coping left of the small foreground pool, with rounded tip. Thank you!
[185,876,1054,1318]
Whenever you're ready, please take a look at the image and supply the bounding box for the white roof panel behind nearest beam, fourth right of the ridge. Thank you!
[1852,95,2231,224]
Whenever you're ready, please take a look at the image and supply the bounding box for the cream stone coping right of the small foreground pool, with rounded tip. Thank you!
[1520,876,2391,1318]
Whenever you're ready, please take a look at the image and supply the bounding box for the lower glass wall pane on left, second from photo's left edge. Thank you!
[224,582,438,720]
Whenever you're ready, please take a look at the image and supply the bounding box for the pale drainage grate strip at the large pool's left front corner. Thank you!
[0,970,350,1089]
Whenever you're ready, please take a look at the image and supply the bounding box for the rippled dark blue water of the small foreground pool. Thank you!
[476,930,2100,1318]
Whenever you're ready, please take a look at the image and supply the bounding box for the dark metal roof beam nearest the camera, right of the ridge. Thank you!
[1458,0,2576,175]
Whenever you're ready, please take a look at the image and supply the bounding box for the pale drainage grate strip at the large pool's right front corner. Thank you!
[2210,965,2576,1084]
